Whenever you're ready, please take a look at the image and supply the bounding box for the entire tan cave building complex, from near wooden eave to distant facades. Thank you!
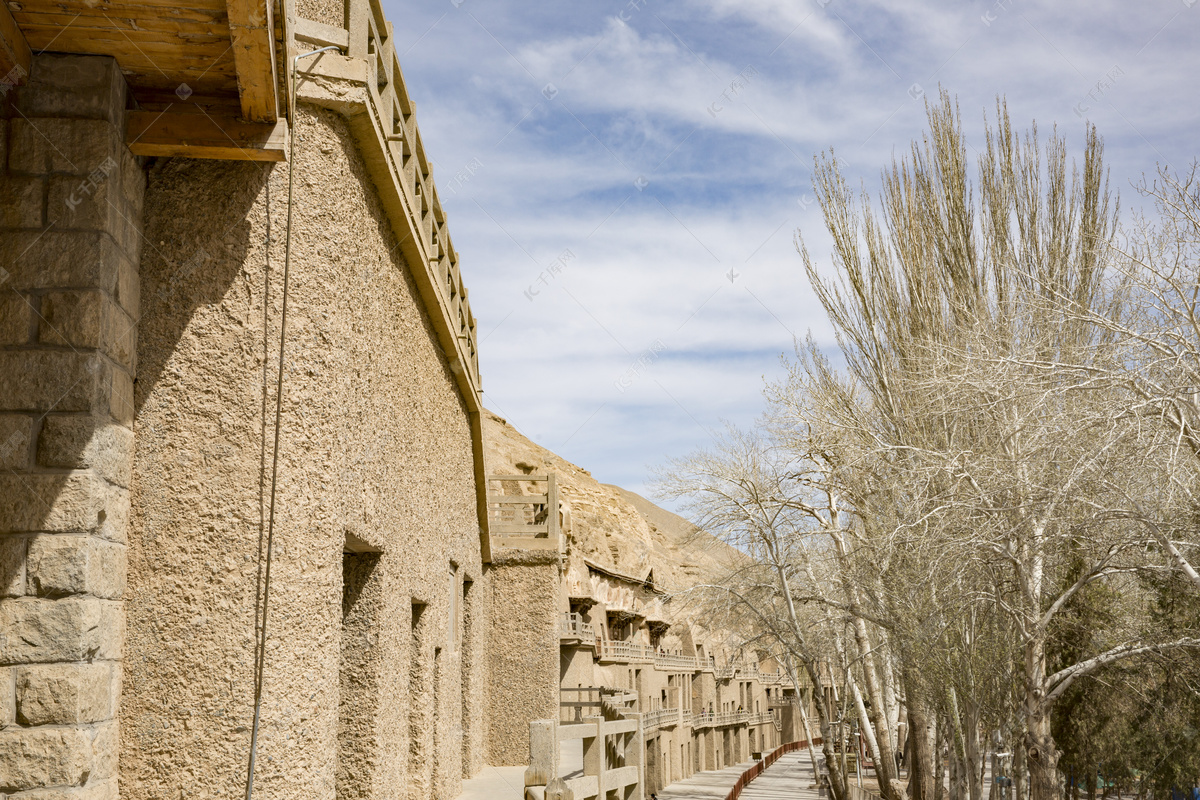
[0,0,804,800]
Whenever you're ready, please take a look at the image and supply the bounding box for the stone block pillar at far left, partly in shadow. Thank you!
[0,55,143,799]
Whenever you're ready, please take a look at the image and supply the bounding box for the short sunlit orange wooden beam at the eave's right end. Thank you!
[226,0,280,122]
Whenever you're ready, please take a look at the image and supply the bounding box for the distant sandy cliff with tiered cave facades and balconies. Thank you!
[484,414,808,796]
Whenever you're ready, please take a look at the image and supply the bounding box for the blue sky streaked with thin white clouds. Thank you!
[384,0,1200,506]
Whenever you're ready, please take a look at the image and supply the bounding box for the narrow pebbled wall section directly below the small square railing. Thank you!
[487,548,560,766]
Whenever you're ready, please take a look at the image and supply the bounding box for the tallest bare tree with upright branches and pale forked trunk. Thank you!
[800,94,1196,800]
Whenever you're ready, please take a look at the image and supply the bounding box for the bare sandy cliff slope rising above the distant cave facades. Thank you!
[484,411,737,591]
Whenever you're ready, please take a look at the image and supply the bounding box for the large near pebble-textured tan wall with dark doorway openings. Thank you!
[121,107,480,799]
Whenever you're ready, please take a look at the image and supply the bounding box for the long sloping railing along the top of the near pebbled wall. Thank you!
[288,0,480,403]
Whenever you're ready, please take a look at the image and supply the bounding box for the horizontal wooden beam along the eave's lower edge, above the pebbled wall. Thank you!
[125,112,288,161]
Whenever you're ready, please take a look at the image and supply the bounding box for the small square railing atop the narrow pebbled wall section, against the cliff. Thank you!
[487,473,556,551]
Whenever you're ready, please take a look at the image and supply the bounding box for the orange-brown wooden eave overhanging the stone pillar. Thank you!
[7,0,287,161]
